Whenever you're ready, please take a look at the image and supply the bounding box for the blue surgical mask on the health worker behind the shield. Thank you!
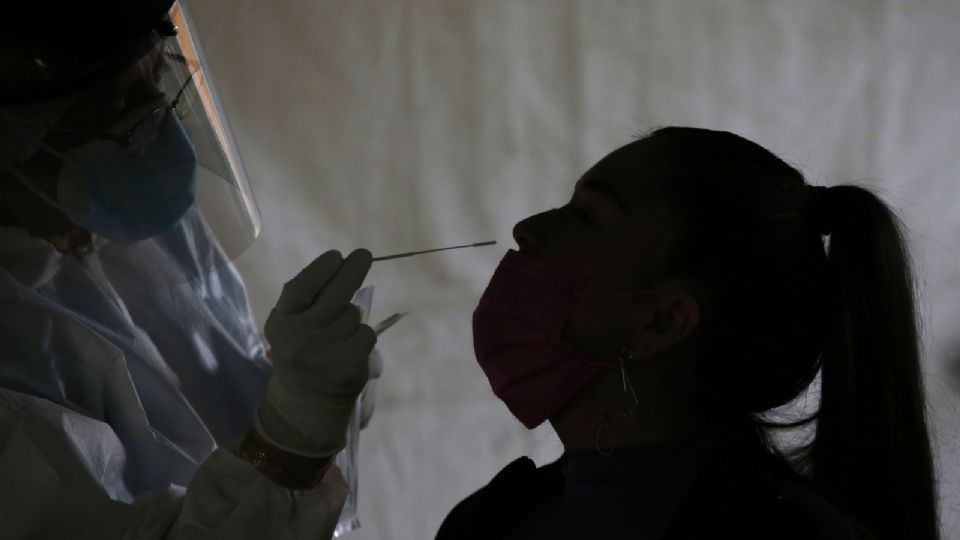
[11,114,197,244]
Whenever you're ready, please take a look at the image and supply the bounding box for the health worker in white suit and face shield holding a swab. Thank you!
[0,0,378,539]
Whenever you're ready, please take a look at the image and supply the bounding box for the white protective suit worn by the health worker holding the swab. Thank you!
[0,206,348,540]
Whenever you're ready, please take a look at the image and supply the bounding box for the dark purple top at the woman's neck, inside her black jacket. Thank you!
[505,429,736,540]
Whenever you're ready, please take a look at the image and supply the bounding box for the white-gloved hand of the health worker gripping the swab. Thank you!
[254,249,377,458]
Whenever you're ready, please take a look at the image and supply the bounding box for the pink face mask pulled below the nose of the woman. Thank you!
[473,249,668,429]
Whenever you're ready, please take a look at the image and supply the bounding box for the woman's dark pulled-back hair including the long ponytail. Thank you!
[635,127,939,540]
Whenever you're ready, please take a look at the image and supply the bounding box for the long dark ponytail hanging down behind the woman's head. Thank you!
[802,186,939,540]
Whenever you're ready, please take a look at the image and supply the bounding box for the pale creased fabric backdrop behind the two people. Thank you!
[190,0,960,540]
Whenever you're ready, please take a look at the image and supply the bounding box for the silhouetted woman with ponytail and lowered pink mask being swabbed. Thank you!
[437,127,939,540]
